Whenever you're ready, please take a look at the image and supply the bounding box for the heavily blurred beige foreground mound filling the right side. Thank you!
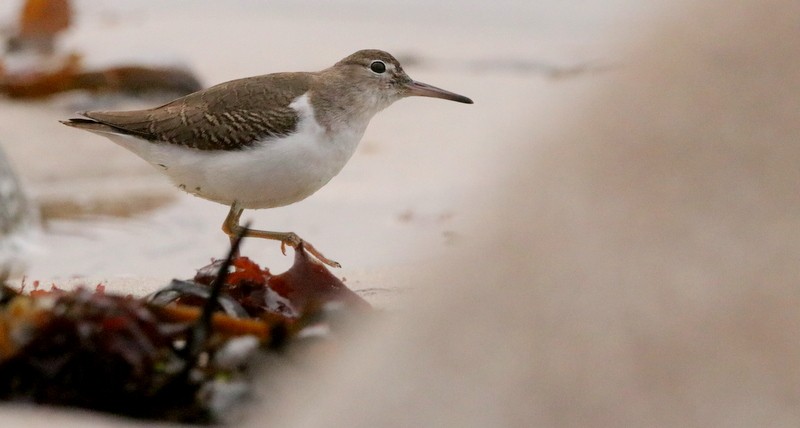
[0,0,800,427]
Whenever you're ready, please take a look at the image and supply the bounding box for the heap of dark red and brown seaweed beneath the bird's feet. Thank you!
[0,231,370,424]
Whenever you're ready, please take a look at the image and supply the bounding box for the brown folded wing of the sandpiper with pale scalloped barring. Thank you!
[75,73,313,150]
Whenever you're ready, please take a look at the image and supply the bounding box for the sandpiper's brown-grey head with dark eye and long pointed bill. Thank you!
[334,49,472,104]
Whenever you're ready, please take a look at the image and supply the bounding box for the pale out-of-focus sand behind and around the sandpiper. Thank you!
[0,0,643,280]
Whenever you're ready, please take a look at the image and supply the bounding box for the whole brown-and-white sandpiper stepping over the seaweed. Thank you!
[62,49,472,267]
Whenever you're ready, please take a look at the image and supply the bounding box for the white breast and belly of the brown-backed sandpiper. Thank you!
[98,94,369,208]
